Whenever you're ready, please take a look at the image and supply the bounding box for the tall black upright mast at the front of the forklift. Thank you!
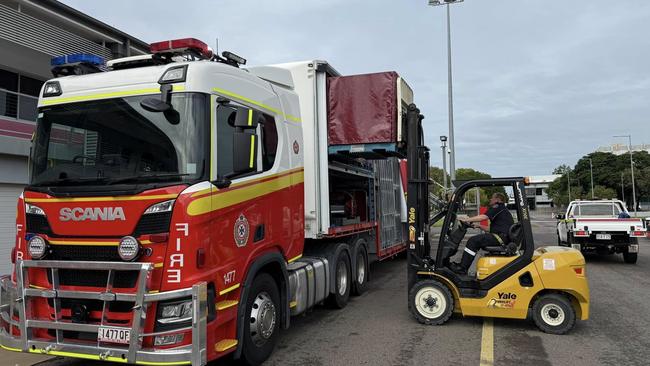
[406,104,432,289]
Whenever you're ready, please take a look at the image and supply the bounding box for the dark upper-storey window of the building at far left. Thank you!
[0,69,43,121]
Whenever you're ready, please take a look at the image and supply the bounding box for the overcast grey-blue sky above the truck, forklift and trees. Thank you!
[63,0,650,176]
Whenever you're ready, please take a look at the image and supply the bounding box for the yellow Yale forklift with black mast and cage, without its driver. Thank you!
[407,105,589,334]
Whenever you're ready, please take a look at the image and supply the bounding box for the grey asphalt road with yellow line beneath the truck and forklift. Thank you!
[5,220,650,366]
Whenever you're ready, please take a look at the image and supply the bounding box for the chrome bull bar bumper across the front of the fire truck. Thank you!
[0,260,208,366]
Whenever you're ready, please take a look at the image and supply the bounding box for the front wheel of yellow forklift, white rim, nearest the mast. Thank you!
[409,280,454,325]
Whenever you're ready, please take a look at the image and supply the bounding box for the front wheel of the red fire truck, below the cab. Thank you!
[241,273,282,366]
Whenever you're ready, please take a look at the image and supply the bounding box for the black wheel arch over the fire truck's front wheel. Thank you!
[234,252,291,359]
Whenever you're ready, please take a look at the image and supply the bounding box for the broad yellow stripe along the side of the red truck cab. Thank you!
[187,171,304,216]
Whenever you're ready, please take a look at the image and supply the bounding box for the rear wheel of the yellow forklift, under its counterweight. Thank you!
[533,294,576,334]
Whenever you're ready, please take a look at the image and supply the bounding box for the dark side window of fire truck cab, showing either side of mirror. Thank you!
[216,105,278,177]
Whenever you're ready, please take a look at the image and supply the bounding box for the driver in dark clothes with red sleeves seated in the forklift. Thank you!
[450,192,514,274]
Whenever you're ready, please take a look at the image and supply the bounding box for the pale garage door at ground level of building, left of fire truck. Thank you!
[0,184,23,274]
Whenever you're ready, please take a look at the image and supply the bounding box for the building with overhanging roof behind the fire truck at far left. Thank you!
[0,0,149,274]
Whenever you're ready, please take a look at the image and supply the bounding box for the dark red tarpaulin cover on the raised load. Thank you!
[327,71,398,145]
